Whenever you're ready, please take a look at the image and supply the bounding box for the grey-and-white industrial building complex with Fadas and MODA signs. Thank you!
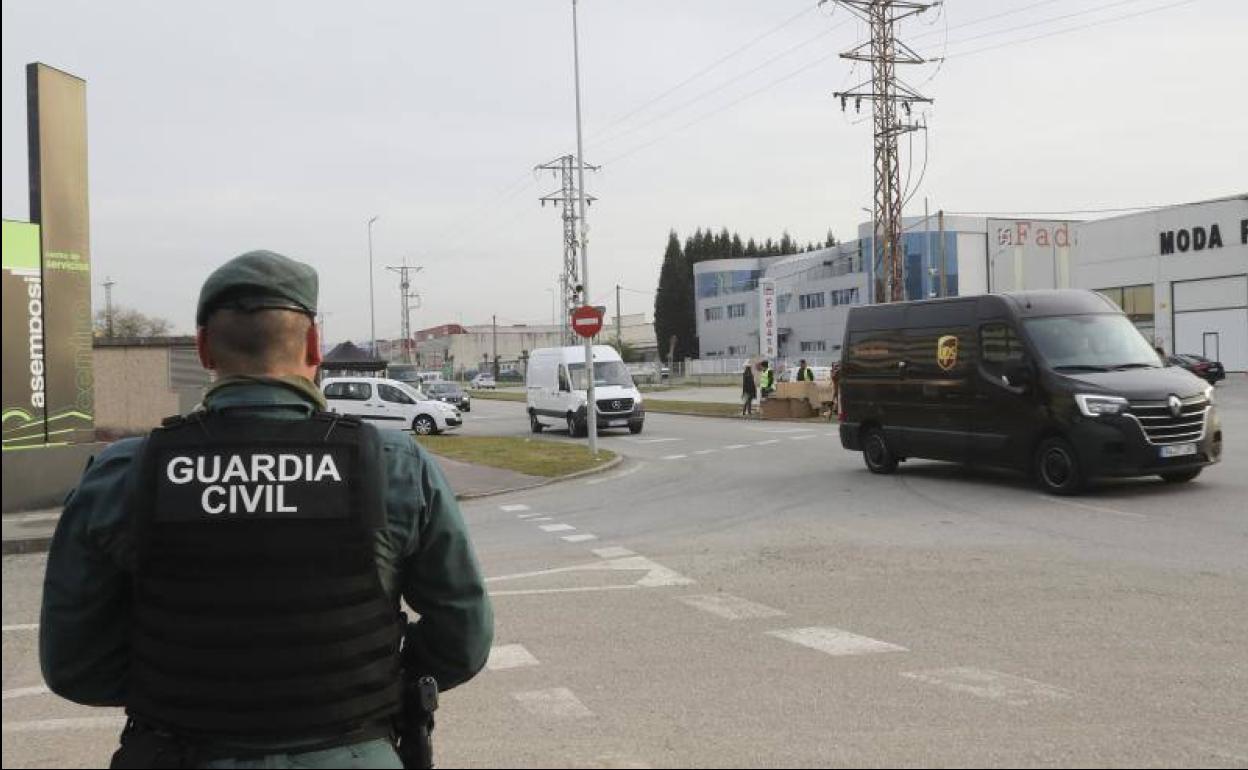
[694,193,1248,372]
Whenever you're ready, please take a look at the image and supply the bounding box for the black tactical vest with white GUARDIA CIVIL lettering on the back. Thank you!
[127,414,401,741]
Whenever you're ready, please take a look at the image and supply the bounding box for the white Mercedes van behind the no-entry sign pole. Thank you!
[524,344,645,436]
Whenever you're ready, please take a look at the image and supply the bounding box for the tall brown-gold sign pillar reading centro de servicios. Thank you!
[26,64,95,443]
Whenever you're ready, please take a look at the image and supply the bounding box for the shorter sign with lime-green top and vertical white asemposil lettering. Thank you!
[0,220,47,449]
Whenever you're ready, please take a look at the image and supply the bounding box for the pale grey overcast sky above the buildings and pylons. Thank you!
[2,0,1248,341]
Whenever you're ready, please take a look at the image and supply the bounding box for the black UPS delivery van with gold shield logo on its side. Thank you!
[841,290,1222,494]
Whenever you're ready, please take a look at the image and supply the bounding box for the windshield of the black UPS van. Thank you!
[1023,313,1162,372]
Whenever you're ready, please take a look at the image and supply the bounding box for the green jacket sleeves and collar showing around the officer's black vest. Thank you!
[39,377,494,758]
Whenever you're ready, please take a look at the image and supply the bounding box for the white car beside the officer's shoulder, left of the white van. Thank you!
[321,377,463,436]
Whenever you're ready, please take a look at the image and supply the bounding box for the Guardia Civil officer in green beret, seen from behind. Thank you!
[40,251,493,768]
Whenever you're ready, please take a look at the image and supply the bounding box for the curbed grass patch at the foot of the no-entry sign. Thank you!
[416,436,615,478]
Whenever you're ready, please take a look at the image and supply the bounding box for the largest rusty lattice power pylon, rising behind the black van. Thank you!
[820,0,938,302]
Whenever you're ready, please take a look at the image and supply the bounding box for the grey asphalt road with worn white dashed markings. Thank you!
[4,383,1248,768]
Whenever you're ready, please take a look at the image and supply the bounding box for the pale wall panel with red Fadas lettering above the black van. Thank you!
[988,220,1075,292]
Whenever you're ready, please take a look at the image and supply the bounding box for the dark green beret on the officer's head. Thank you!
[195,251,317,326]
